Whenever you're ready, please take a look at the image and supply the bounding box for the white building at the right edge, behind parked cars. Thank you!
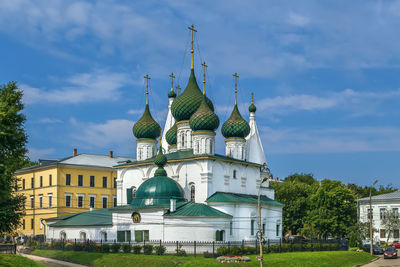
[357,191,400,242]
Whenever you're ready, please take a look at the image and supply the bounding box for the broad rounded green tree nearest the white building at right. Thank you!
[302,179,357,238]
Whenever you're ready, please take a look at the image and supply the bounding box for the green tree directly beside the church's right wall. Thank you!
[271,174,318,235]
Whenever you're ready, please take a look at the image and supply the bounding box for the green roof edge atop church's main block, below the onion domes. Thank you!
[114,149,263,168]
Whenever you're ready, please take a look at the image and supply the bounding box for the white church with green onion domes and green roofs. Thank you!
[46,27,283,245]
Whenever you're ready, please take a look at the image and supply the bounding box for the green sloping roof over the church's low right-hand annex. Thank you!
[206,192,284,206]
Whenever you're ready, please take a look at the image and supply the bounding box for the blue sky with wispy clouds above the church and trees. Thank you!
[0,0,400,187]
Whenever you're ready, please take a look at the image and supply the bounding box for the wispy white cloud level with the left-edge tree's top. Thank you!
[20,70,134,104]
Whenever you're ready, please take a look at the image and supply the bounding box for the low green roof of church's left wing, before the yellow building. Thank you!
[48,209,112,227]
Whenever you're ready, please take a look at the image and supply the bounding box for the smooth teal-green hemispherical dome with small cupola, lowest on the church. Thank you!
[131,149,186,207]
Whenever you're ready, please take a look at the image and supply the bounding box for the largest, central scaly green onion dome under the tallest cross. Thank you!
[171,69,214,121]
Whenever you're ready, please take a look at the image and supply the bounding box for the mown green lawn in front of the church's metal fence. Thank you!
[32,250,375,267]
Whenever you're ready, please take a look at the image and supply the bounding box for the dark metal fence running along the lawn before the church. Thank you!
[32,239,348,257]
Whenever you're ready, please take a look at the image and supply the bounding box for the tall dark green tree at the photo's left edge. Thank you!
[0,82,29,233]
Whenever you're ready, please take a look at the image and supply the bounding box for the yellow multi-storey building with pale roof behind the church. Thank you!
[15,149,134,239]
